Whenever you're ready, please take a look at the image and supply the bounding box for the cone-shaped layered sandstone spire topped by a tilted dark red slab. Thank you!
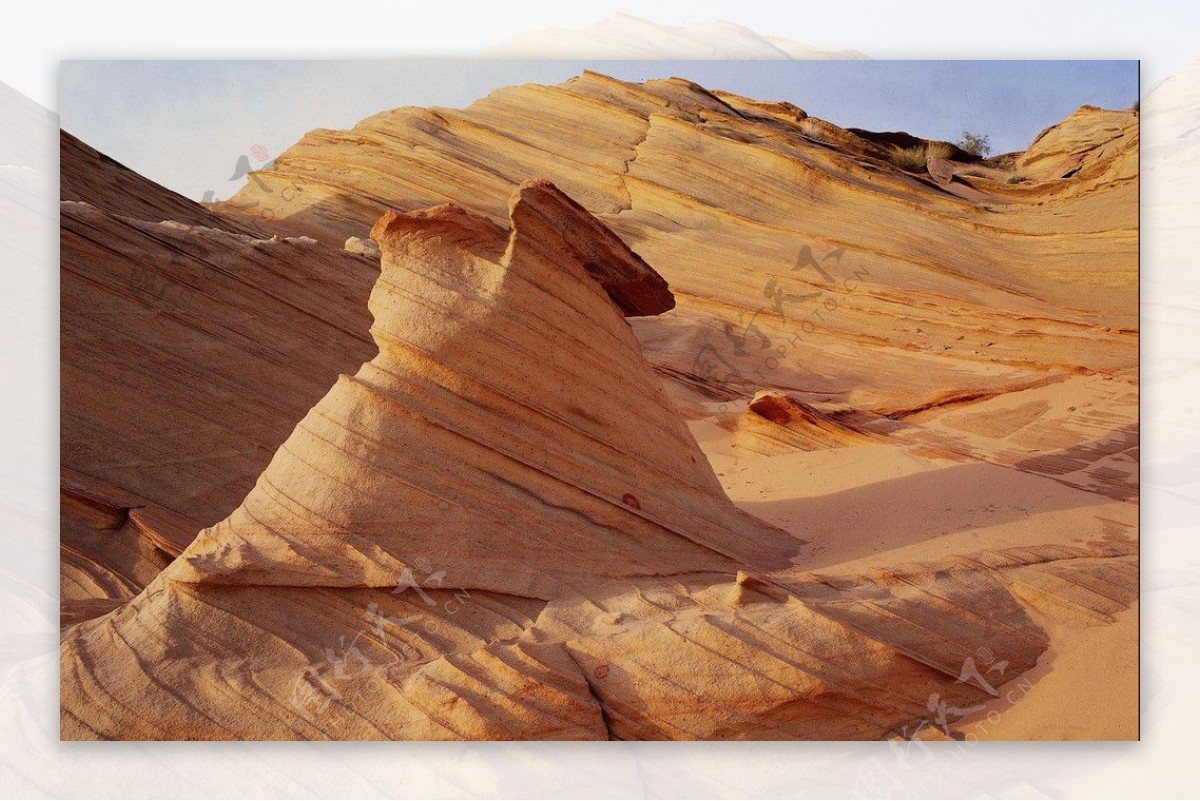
[166,181,802,598]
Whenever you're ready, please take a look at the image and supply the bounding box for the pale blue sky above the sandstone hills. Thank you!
[59,59,1138,199]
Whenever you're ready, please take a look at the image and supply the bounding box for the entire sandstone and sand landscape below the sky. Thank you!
[61,73,1139,739]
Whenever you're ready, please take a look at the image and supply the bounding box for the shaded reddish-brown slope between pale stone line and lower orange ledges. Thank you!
[61,203,378,523]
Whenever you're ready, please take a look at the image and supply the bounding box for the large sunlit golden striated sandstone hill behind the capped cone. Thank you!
[221,72,1139,506]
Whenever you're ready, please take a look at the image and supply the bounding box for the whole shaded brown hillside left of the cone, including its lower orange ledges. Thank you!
[59,132,378,622]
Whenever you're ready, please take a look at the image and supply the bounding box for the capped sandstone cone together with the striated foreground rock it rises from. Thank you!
[61,182,1135,739]
